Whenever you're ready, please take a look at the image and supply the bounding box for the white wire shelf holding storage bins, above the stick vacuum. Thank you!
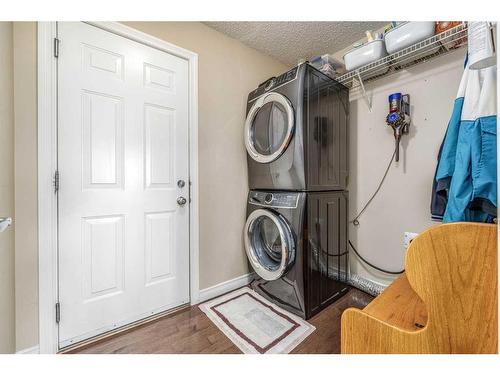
[337,22,467,90]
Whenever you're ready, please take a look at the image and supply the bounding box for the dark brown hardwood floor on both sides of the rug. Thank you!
[68,288,373,354]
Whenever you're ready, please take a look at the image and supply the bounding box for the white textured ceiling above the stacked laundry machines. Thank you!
[205,22,387,65]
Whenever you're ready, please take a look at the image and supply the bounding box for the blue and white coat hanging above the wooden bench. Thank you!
[431,59,497,222]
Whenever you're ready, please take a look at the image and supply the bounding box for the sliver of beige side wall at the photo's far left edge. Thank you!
[0,22,15,354]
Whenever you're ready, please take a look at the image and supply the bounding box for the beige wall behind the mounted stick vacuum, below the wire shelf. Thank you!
[349,50,465,284]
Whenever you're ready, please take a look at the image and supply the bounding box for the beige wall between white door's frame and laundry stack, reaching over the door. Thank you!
[122,22,287,289]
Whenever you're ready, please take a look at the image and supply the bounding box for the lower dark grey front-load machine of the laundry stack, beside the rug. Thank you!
[244,190,348,319]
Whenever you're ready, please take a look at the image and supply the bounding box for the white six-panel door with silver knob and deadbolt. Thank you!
[58,22,189,347]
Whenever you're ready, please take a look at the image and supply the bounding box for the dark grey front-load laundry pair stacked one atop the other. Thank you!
[244,63,349,319]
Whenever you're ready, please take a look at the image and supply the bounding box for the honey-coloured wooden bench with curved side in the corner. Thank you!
[341,223,498,354]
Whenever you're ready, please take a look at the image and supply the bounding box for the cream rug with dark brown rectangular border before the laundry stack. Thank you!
[200,287,315,354]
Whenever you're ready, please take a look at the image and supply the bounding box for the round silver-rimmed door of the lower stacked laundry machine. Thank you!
[245,209,295,280]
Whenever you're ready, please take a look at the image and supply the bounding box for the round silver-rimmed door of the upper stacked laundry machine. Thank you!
[245,93,294,163]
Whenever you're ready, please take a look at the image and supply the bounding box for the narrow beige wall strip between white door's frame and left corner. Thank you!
[13,22,38,350]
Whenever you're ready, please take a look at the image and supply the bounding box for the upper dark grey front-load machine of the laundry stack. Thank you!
[244,63,349,191]
